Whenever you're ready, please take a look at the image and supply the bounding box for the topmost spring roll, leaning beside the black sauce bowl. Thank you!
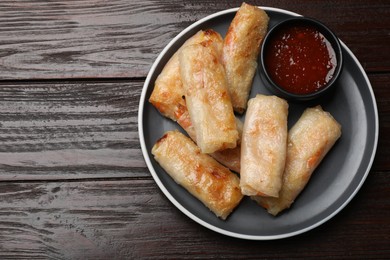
[222,3,269,113]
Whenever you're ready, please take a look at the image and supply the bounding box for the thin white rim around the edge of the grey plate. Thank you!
[138,6,379,240]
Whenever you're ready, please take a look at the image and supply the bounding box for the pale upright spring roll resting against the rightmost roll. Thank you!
[240,95,288,197]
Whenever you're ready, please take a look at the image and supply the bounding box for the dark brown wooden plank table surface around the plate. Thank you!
[0,0,390,259]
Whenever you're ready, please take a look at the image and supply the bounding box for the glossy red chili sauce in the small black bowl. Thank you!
[265,25,337,94]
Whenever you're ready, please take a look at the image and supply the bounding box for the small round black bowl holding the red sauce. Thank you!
[260,17,343,101]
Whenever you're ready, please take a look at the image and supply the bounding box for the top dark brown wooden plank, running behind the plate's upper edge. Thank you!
[0,0,390,79]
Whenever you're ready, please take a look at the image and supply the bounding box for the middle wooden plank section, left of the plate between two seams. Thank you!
[0,81,149,180]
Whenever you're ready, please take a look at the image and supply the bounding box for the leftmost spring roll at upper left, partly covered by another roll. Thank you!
[149,29,223,121]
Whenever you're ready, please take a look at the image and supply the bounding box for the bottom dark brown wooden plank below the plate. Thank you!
[0,178,390,259]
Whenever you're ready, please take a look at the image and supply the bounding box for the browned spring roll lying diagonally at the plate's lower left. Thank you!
[152,131,243,219]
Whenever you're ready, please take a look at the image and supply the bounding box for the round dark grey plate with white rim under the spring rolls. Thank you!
[138,7,378,240]
